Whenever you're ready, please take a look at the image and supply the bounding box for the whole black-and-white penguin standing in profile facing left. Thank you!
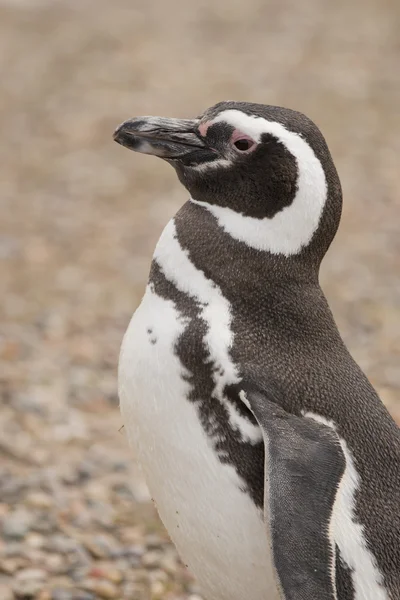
[114,102,400,600]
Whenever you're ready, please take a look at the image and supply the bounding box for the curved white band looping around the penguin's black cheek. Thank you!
[192,110,327,256]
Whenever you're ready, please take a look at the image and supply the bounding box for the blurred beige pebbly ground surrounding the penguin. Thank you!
[0,0,400,600]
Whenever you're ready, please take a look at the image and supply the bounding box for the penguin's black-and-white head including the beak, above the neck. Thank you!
[114,102,342,261]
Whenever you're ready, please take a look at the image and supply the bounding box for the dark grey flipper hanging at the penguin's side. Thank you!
[240,390,345,600]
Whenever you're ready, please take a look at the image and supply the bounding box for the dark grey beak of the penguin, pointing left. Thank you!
[114,117,210,160]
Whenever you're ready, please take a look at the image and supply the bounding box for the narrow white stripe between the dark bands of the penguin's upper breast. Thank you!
[154,219,262,444]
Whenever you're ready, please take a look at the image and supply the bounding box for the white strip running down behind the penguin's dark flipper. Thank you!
[303,412,389,600]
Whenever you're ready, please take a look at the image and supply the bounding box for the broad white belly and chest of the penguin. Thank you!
[119,288,279,600]
